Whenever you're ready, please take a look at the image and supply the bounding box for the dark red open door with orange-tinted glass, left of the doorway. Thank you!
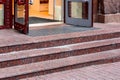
[14,0,29,34]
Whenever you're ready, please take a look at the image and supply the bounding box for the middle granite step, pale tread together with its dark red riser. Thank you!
[0,38,120,68]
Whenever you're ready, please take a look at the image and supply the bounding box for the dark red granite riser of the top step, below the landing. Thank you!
[0,32,120,53]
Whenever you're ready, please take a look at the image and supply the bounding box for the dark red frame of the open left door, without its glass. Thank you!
[14,0,29,34]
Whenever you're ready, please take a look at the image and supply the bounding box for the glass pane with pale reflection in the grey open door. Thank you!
[68,1,88,19]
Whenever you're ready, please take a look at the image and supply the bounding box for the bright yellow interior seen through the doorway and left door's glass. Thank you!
[12,0,63,24]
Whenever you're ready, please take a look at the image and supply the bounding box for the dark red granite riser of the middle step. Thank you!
[0,43,120,68]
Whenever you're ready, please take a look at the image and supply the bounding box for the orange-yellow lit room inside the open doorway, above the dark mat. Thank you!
[29,0,53,19]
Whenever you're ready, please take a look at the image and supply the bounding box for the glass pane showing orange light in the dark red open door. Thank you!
[15,4,25,24]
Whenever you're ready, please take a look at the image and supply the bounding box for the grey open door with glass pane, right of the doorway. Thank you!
[64,0,93,27]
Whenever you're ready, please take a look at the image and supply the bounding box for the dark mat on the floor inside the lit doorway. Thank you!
[17,17,59,24]
